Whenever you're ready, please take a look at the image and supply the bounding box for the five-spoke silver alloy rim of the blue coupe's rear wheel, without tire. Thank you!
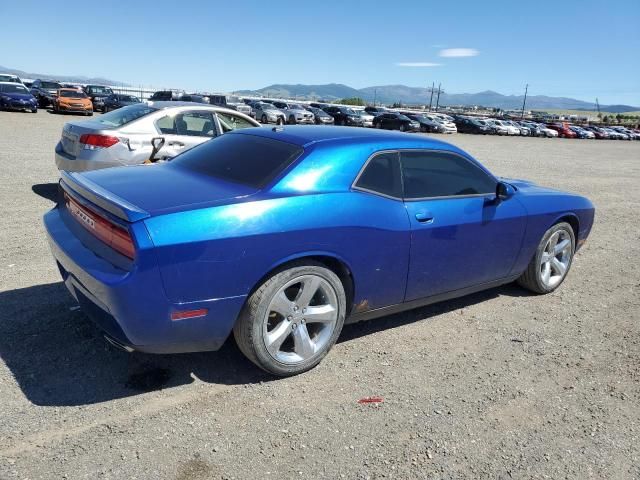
[262,275,338,365]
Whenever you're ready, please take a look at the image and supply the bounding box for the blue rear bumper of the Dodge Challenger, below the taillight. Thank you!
[44,207,246,353]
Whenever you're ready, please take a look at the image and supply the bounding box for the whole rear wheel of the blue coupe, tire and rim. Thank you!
[233,261,346,376]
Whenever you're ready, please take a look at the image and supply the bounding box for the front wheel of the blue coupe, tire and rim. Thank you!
[518,222,576,293]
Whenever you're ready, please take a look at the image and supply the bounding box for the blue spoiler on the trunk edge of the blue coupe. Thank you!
[60,171,151,222]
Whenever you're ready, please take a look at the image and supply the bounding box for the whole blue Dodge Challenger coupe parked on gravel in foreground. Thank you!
[44,126,594,376]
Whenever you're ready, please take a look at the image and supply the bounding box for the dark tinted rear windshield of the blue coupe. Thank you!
[171,134,303,188]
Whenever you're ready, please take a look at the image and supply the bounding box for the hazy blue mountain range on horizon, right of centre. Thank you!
[236,83,640,113]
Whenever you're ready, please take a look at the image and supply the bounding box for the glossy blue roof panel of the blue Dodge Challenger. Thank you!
[232,125,457,150]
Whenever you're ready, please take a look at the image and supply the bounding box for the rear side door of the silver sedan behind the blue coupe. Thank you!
[155,110,218,159]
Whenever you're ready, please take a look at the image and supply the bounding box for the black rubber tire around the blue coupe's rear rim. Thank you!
[233,260,347,377]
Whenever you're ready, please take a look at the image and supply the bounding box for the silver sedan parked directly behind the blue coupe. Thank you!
[55,102,260,172]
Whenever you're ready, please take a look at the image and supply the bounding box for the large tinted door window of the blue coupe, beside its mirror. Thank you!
[401,151,496,199]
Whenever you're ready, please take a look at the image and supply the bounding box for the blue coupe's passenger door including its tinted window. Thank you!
[400,150,526,301]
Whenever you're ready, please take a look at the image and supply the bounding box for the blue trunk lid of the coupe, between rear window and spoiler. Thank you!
[79,163,257,215]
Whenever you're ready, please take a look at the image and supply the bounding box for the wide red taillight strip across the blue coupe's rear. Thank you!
[64,193,136,259]
